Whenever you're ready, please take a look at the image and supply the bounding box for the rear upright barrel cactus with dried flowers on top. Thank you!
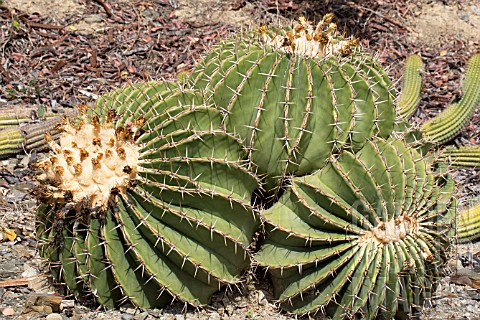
[191,15,394,190]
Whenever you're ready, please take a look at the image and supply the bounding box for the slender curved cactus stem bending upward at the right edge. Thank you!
[421,54,480,144]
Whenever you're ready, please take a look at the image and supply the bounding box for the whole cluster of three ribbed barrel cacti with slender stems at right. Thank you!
[34,15,480,319]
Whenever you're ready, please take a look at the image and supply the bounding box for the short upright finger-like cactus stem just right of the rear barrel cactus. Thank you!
[397,55,424,119]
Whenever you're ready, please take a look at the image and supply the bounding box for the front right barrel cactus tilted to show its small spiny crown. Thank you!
[256,139,455,319]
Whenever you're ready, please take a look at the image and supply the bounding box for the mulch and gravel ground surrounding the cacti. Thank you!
[0,0,480,320]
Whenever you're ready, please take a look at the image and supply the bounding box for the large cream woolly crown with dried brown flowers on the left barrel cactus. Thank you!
[36,110,143,209]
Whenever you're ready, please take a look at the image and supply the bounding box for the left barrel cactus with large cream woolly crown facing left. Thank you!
[36,82,259,308]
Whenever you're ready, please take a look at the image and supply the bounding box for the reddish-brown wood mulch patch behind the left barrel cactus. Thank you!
[0,0,231,108]
